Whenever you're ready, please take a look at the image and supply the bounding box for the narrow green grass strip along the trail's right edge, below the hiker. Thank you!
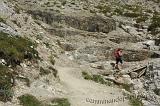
[82,71,112,86]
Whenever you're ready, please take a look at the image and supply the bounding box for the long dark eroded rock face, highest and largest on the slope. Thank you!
[28,11,116,33]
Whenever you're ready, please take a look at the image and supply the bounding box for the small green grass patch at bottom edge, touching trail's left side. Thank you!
[51,98,71,106]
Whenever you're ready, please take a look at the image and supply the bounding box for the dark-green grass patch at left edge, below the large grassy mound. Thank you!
[0,64,14,102]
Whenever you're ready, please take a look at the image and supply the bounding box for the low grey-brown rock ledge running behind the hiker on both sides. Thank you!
[72,46,160,62]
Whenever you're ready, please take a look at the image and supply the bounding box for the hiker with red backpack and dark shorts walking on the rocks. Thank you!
[114,48,123,70]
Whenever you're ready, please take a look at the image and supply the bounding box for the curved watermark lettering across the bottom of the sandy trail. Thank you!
[86,95,160,105]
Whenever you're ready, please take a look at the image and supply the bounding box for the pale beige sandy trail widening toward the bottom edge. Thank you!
[56,55,129,106]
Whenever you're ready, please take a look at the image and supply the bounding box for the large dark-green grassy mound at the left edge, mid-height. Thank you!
[0,32,39,66]
